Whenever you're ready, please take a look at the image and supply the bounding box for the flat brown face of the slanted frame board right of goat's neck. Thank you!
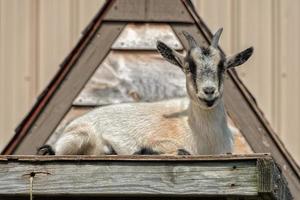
[224,72,300,198]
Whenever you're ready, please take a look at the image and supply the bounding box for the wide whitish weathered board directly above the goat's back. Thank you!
[73,51,186,106]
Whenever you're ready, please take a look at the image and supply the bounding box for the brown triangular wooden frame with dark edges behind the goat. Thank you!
[2,0,300,197]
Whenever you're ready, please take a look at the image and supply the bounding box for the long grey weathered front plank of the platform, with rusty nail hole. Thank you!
[0,157,258,196]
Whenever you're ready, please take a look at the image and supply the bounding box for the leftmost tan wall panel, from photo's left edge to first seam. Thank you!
[0,0,37,152]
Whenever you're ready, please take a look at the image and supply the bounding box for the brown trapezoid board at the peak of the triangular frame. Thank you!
[104,0,194,23]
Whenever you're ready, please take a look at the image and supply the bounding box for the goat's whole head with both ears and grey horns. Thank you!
[157,28,253,109]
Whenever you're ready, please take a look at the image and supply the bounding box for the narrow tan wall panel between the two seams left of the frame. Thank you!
[38,0,72,91]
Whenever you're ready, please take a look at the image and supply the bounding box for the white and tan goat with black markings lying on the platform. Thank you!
[39,28,253,155]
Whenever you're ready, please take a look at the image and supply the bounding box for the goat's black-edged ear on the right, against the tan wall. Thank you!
[225,47,254,69]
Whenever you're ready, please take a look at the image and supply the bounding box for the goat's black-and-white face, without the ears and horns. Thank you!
[186,47,225,108]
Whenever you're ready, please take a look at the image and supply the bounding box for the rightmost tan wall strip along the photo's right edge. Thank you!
[275,0,300,163]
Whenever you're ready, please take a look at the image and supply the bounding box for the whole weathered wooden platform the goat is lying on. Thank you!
[0,154,292,200]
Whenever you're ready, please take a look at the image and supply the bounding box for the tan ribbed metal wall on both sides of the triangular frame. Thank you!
[0,0,300,162]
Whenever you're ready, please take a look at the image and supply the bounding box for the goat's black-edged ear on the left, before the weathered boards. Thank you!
[156,41,184,69]
